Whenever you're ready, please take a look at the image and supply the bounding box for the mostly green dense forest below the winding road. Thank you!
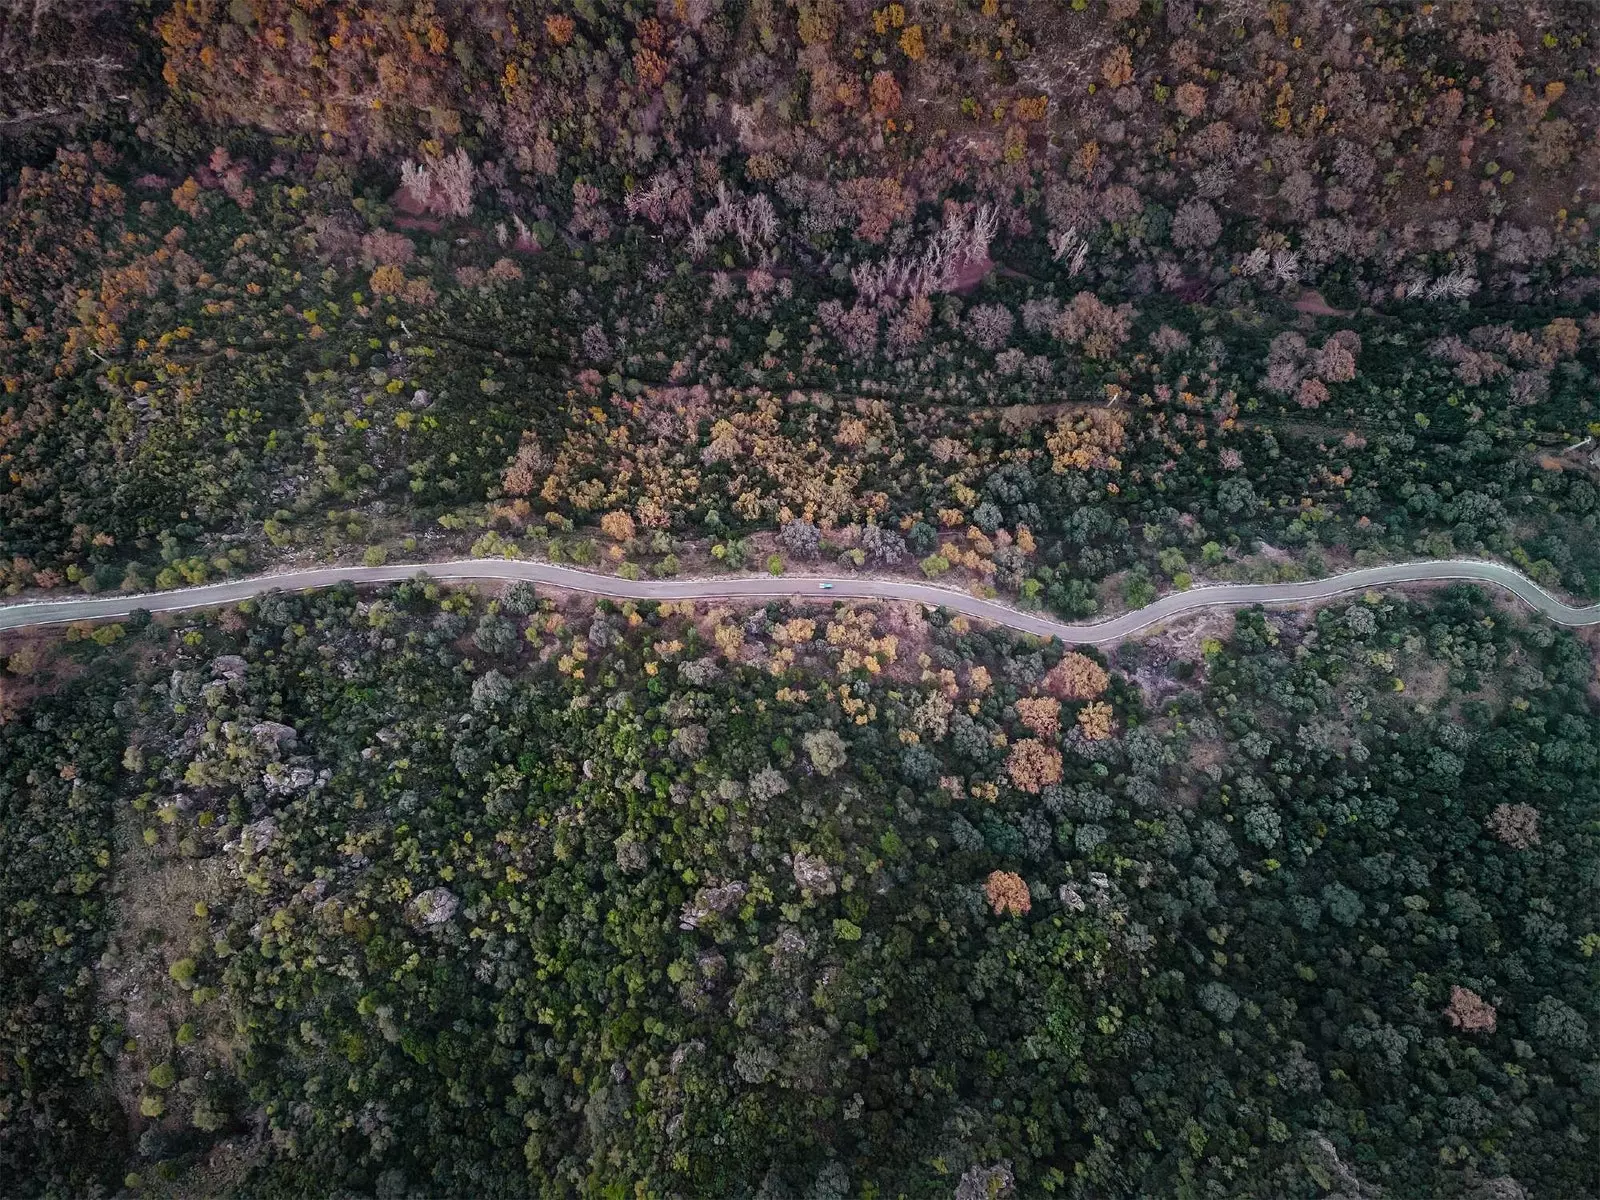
[0,581,1600,1197]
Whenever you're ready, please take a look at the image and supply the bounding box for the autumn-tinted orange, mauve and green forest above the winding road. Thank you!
[0,0,1600,616]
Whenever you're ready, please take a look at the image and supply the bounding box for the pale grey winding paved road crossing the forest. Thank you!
[0,558,1600,645]
